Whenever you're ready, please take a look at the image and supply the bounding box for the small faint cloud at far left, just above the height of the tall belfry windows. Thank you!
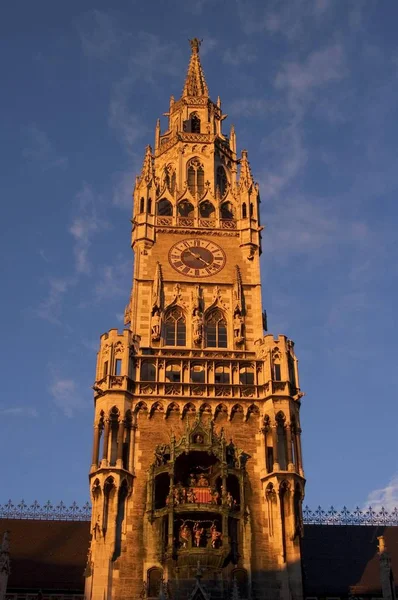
[22,123,68,171]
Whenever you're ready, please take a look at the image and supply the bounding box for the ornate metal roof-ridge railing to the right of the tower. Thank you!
[303,506,398,525]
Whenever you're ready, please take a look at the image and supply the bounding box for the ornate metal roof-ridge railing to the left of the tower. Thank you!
[0,500,91,521]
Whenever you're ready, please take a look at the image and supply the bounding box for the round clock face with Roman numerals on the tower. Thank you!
[169,238,226,277]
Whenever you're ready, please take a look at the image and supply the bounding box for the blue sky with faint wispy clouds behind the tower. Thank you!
[0,0,398,508]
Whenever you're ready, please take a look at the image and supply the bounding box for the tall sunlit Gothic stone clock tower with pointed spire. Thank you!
[85,38,304,600]
